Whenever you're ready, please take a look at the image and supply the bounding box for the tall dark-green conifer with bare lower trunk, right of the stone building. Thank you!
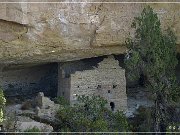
[125,6,180,132]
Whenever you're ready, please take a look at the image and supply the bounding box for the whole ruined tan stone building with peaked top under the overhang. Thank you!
[58,56,127,110]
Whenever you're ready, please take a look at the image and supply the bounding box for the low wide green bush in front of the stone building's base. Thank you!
[56,96,128,132]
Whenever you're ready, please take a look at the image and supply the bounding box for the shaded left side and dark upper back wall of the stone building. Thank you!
[57,57,103,100]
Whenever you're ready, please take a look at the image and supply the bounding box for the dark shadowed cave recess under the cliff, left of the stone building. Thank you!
[0,63,58,100]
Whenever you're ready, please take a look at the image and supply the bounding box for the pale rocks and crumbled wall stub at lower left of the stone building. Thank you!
[3,92,60,132]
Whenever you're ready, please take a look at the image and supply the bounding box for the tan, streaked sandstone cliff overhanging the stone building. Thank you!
[0,0,180,64]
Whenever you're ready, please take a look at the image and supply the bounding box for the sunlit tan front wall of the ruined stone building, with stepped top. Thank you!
[70,56,127,110]
